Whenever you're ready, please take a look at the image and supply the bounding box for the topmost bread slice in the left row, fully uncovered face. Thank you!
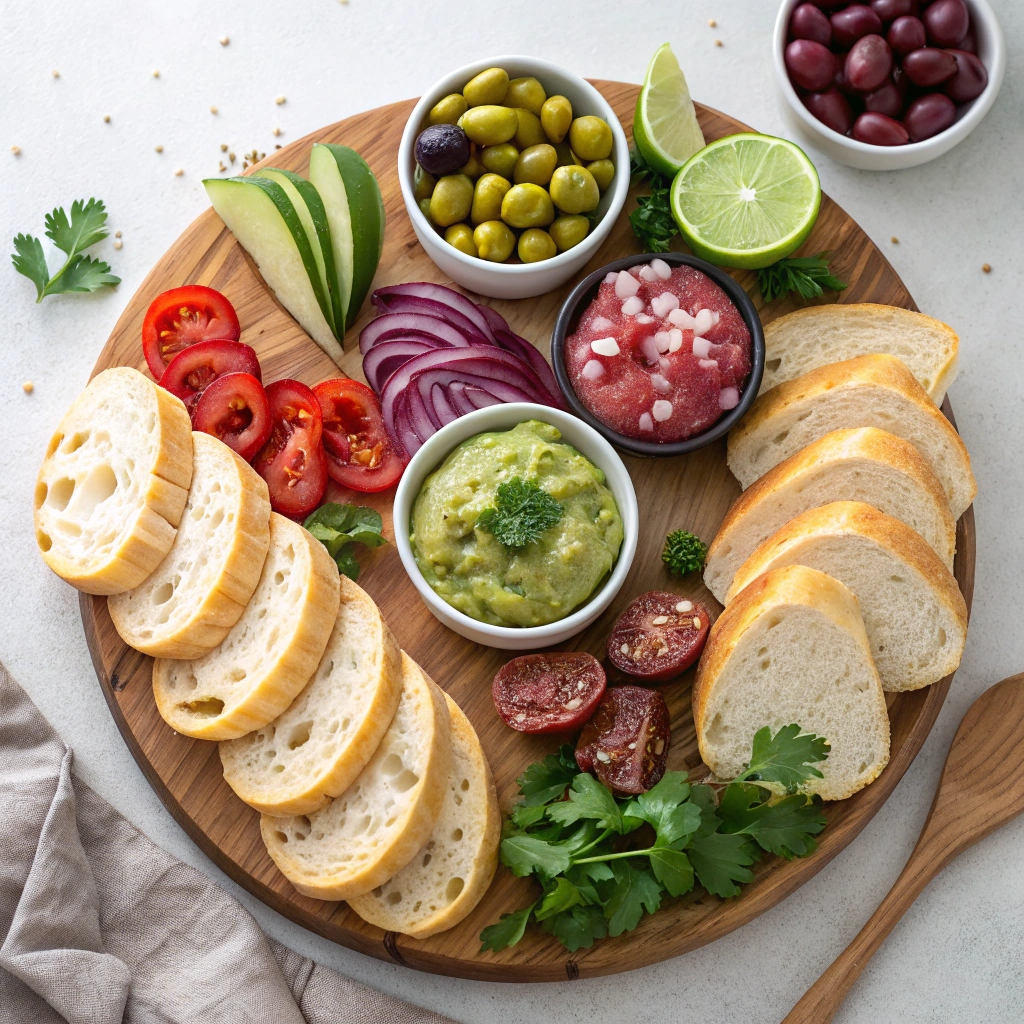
[35,367,193,594]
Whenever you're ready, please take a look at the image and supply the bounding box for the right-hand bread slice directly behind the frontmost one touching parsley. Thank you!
[726,502,967,690]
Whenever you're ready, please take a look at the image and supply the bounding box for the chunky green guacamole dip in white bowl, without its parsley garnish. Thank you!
[410,420,623,626]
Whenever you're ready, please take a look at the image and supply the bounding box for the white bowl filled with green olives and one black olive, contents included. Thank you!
[398,56,630,299]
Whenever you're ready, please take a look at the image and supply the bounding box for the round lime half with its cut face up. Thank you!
[672,133,821,269]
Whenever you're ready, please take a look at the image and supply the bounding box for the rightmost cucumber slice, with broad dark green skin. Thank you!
[309,143,384,330]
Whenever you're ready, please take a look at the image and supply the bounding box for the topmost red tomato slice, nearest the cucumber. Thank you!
[142,285,242,381]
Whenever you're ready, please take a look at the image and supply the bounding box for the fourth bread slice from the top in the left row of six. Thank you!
[220,577,402,816]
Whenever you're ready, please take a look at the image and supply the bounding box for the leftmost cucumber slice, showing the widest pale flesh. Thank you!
[203,176,343,362]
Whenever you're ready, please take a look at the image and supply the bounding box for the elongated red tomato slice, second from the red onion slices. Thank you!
[253,378,327,519]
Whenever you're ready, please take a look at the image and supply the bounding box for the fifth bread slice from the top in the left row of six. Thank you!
[260,652,452,900]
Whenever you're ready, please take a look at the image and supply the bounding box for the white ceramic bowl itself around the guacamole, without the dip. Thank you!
[394,401,640,650]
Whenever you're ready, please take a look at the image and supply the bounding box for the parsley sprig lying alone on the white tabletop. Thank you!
[10,199,121,302]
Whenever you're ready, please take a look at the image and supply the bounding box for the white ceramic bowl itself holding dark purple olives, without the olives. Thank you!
[773,0,1007,171]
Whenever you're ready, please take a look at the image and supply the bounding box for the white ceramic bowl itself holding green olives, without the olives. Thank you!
[398,56,630,299]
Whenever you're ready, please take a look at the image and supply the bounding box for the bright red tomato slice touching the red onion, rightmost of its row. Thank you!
[313,377,406,494]
